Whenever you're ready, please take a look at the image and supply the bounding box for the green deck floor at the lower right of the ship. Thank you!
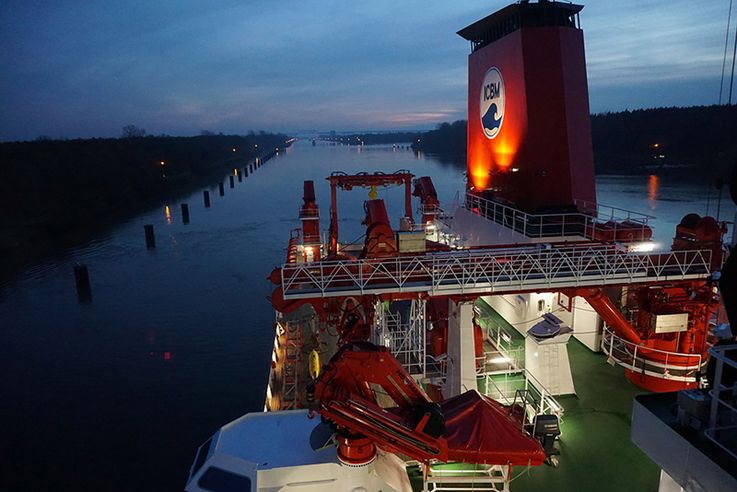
[511,338,660,492]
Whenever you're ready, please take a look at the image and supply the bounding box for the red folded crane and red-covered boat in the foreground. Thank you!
[308,342,547,466]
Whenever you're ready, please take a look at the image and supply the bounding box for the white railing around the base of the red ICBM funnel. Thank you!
[465,192,653,240]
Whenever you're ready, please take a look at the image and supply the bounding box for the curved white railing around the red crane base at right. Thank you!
[601,326,703,383]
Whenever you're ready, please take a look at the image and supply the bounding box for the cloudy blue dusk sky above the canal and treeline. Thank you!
[0,0,737,140]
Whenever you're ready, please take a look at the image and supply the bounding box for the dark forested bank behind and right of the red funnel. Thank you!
[344,106,737,180]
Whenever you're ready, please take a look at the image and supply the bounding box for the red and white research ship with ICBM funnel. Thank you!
[186,0,737,492]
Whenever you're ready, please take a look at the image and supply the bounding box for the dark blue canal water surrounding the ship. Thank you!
[0,142,735,492]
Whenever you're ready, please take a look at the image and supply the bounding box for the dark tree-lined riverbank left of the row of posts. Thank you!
[0,133,291,278]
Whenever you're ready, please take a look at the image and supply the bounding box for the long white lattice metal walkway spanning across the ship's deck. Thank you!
[281,244,711,299]
